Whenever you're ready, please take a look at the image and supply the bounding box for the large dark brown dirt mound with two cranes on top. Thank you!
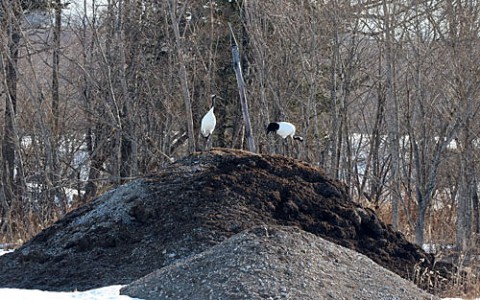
[0,149,442,290]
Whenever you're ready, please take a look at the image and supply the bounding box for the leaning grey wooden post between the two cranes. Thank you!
[228,23,257,152]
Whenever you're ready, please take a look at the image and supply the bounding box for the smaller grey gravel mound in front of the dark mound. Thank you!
[121,226,437,300]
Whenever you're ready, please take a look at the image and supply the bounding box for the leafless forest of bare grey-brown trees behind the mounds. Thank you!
[0,0,480,250]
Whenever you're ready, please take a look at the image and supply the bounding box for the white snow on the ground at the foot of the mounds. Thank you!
[0,248,474,300]
